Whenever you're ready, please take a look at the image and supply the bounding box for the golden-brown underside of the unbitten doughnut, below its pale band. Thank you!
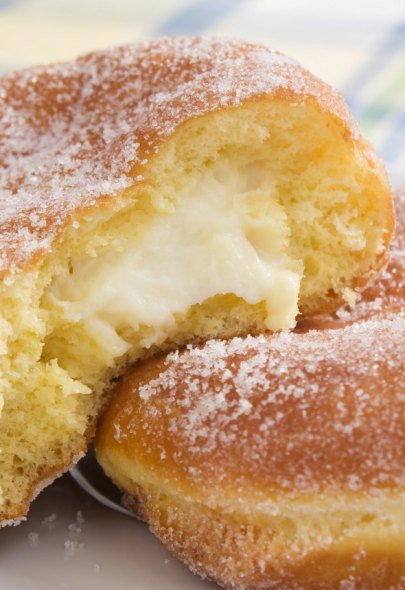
[124,486,405,590]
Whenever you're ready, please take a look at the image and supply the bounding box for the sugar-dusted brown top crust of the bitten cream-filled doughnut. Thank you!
[0,38,357,273]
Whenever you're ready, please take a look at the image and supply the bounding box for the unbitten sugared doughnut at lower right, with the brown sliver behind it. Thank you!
[95,191,405,590]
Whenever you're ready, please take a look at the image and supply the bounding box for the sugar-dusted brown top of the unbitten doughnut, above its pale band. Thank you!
[120,196,405,493]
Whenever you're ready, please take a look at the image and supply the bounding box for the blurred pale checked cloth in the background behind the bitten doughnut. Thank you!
[0,0,405,184]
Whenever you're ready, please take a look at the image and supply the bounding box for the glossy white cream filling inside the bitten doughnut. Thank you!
[49,169,302,356]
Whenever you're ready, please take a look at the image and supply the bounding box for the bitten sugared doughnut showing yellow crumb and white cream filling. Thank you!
[0,38,393,524]
